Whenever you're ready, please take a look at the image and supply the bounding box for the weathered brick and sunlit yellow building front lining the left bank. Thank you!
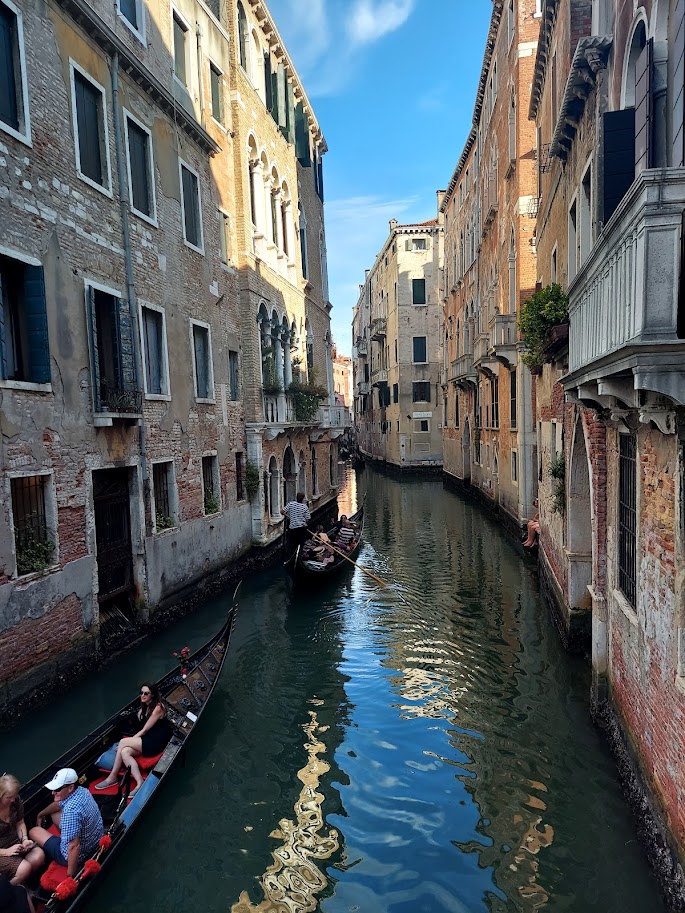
[0,0,339,702]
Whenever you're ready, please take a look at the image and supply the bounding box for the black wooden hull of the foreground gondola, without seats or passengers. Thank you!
[21,591,237,913]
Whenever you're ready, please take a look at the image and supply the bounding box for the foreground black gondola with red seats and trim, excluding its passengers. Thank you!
[20,588,238,913]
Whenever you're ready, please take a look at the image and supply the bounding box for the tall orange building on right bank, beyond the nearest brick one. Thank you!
[440,0,540,527]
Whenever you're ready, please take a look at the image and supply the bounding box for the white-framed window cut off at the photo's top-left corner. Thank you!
[0,0,31,143]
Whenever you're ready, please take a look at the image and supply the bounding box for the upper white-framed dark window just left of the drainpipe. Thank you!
[71,61,111,196]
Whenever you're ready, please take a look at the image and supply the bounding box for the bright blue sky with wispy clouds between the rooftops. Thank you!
[268,0,492,355]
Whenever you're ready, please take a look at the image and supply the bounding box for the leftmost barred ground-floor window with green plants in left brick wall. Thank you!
[10,475,55,577]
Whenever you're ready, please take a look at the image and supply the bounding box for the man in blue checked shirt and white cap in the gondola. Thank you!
[30,767,104,878]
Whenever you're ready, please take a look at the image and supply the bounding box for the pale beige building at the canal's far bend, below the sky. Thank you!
[353,219,442,469]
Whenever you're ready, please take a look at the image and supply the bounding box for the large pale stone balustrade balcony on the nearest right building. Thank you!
[562,168,685,422]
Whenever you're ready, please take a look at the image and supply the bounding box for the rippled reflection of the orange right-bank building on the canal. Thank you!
[366,470,553,911]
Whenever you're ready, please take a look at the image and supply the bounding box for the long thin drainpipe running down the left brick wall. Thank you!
[111,51,150,536]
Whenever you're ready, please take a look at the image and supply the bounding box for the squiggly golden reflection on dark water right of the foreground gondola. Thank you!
[231,712,340,913]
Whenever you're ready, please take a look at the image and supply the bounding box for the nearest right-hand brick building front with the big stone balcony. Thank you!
[530,0,685,877]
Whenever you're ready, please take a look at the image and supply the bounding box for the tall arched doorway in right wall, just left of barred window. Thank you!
[567,419,593,609]
